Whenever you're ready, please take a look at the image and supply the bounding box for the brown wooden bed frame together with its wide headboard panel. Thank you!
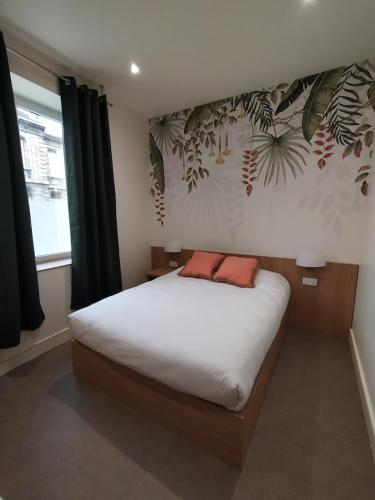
[72,247,358,469]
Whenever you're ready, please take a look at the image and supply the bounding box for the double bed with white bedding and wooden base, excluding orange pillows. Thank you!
[70,269,290,467]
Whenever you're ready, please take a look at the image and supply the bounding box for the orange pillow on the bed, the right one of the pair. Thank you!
[213,256,259,288]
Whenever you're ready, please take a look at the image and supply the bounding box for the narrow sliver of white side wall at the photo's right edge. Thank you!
[353,184,375,458]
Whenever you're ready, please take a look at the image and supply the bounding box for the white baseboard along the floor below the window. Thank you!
[0,328,70,376]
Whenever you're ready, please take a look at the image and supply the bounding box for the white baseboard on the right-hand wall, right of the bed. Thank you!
[349,328,375,462]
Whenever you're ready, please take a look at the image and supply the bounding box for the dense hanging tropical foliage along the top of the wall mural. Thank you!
[150,60,375,225]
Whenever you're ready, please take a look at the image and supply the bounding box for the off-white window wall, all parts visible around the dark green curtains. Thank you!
[0,33,152,375]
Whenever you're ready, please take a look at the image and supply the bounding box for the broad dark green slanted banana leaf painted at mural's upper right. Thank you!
[302,67,344,142]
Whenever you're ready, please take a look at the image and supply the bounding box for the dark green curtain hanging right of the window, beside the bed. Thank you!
[60,77,122,309]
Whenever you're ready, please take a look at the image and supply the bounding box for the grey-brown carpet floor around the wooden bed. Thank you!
[0,333,375,500]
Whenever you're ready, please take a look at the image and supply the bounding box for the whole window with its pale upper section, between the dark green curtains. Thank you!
[12,75,70,261]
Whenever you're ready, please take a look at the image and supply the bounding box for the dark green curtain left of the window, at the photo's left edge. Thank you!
[0,32,44,349]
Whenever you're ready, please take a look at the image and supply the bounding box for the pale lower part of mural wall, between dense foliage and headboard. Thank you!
[152,155,367,263]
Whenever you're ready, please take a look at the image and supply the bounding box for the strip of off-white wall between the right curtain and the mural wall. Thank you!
[109,106,152,288]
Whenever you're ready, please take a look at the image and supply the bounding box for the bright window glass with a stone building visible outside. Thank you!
[17,106,70,257]
